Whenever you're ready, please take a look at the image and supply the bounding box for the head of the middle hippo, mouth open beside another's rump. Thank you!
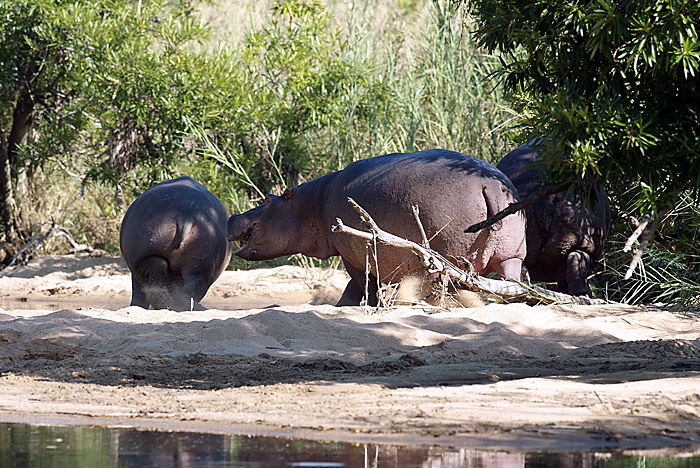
[228,189,308,260]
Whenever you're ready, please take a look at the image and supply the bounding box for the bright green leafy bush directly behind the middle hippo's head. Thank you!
[198,0,388,196]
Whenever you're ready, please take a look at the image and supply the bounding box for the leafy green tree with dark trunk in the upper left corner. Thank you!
[0,0,212,254]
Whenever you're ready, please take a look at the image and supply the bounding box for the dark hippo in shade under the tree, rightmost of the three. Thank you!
[496,142,610,296]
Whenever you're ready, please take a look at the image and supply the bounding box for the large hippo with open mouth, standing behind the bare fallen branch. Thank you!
[228,149,525,306]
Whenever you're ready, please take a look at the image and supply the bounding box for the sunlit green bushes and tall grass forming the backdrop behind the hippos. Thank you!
[0,0,700,307]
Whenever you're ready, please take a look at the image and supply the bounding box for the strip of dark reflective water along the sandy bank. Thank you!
[0,424,700,468]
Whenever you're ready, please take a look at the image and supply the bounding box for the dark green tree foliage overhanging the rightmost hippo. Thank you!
[469,0,700,213]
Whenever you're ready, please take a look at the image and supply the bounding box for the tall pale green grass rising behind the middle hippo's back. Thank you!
[312,0,512,168]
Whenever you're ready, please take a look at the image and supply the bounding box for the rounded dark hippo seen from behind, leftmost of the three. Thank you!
[119,177,233,311]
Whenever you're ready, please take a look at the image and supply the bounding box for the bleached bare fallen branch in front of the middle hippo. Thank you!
[331,198,606,304]
